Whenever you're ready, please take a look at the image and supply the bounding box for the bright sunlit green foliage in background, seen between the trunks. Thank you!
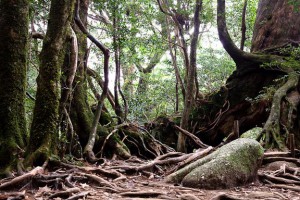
[26,0,257,126]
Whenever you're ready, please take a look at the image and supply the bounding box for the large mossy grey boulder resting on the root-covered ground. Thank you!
[166,138,264,189]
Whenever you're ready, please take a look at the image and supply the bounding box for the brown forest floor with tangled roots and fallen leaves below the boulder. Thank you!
[0,160,300,200]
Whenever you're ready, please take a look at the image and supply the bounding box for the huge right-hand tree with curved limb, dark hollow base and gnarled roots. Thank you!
[193,0,300,148]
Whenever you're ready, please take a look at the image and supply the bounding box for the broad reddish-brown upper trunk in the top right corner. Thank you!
[251,0,300,52]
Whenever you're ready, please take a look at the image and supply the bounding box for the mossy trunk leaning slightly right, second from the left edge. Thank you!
[26,0,75,165]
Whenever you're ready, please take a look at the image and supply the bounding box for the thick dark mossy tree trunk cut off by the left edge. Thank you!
[0,0,29,175]
